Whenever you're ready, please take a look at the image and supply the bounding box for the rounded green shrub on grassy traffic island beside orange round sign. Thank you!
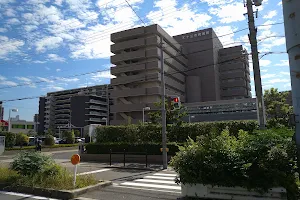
[11,151,54,176]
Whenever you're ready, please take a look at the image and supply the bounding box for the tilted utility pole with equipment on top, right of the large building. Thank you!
[246,0,266,129]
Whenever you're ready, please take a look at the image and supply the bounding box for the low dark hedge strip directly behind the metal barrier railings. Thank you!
[86,143,179,155]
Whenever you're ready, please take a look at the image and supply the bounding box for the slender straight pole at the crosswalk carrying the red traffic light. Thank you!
[160,36,168,169]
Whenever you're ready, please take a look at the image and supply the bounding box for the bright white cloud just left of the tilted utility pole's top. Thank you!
[209,2,246,23]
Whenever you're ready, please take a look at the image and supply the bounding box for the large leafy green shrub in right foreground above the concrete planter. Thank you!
[171,129,298,199]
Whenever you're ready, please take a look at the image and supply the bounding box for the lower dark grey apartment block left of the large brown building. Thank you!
[38,85,110,132]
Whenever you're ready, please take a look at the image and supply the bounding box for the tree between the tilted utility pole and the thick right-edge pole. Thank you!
[264,88,293,119]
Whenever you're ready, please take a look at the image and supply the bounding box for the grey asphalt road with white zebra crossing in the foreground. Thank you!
[0,150,181,200]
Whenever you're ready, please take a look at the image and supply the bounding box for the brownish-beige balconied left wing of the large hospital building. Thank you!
[111,25,188,124]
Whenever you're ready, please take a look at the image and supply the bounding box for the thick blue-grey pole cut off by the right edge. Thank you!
[282,0,300,161]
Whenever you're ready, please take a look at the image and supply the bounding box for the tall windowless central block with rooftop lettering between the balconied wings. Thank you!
[174,28,221,102]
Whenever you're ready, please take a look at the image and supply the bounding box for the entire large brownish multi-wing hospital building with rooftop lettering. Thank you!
[111,25,251,124]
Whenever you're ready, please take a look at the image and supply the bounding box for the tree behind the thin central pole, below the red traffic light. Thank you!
[149,100,187,124]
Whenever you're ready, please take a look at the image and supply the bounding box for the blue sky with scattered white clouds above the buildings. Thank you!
[0,0,290,120]
